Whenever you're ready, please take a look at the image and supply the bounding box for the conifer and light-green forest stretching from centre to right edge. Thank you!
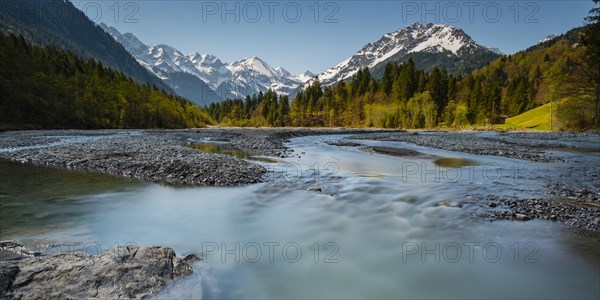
[209,25,598,129]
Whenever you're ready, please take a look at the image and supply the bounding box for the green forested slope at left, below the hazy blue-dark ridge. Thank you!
[0,34,210,129]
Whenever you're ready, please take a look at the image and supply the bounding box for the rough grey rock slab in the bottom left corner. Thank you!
[0,246,197,299]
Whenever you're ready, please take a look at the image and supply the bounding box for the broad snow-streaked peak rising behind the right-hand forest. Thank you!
[310,23,499,85]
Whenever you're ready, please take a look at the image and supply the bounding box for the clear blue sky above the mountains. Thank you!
[78,0,593,73]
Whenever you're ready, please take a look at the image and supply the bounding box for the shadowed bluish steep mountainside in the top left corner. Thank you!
[0,0,171,91]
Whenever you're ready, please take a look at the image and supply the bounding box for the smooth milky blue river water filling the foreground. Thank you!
[0,137,600,299]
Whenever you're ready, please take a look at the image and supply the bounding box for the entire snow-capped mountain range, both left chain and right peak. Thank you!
[100,23,501,104]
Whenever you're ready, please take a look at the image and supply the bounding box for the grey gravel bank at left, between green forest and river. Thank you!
[0,131,266,186]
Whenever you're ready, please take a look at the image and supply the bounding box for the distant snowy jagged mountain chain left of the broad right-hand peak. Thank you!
[100,24,314,104]
